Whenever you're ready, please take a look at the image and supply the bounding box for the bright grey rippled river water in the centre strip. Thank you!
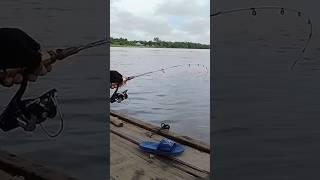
[110,47,210,143]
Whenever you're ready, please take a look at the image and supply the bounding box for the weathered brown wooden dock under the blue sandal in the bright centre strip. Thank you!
[110,111,210,180]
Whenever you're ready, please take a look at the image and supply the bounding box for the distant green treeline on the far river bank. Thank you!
[111,37,210,49]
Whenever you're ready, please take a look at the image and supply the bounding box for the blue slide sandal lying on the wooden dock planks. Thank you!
[139,138,184,156]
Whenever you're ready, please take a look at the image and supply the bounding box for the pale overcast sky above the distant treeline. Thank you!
[110,0,210,44]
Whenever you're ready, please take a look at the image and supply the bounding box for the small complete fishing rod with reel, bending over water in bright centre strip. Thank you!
[110,64,208,103]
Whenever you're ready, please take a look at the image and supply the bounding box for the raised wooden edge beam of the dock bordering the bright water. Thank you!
[110,110,210,153]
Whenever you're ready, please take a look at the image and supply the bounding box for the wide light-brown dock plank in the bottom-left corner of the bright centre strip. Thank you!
[110,133,199,180]
